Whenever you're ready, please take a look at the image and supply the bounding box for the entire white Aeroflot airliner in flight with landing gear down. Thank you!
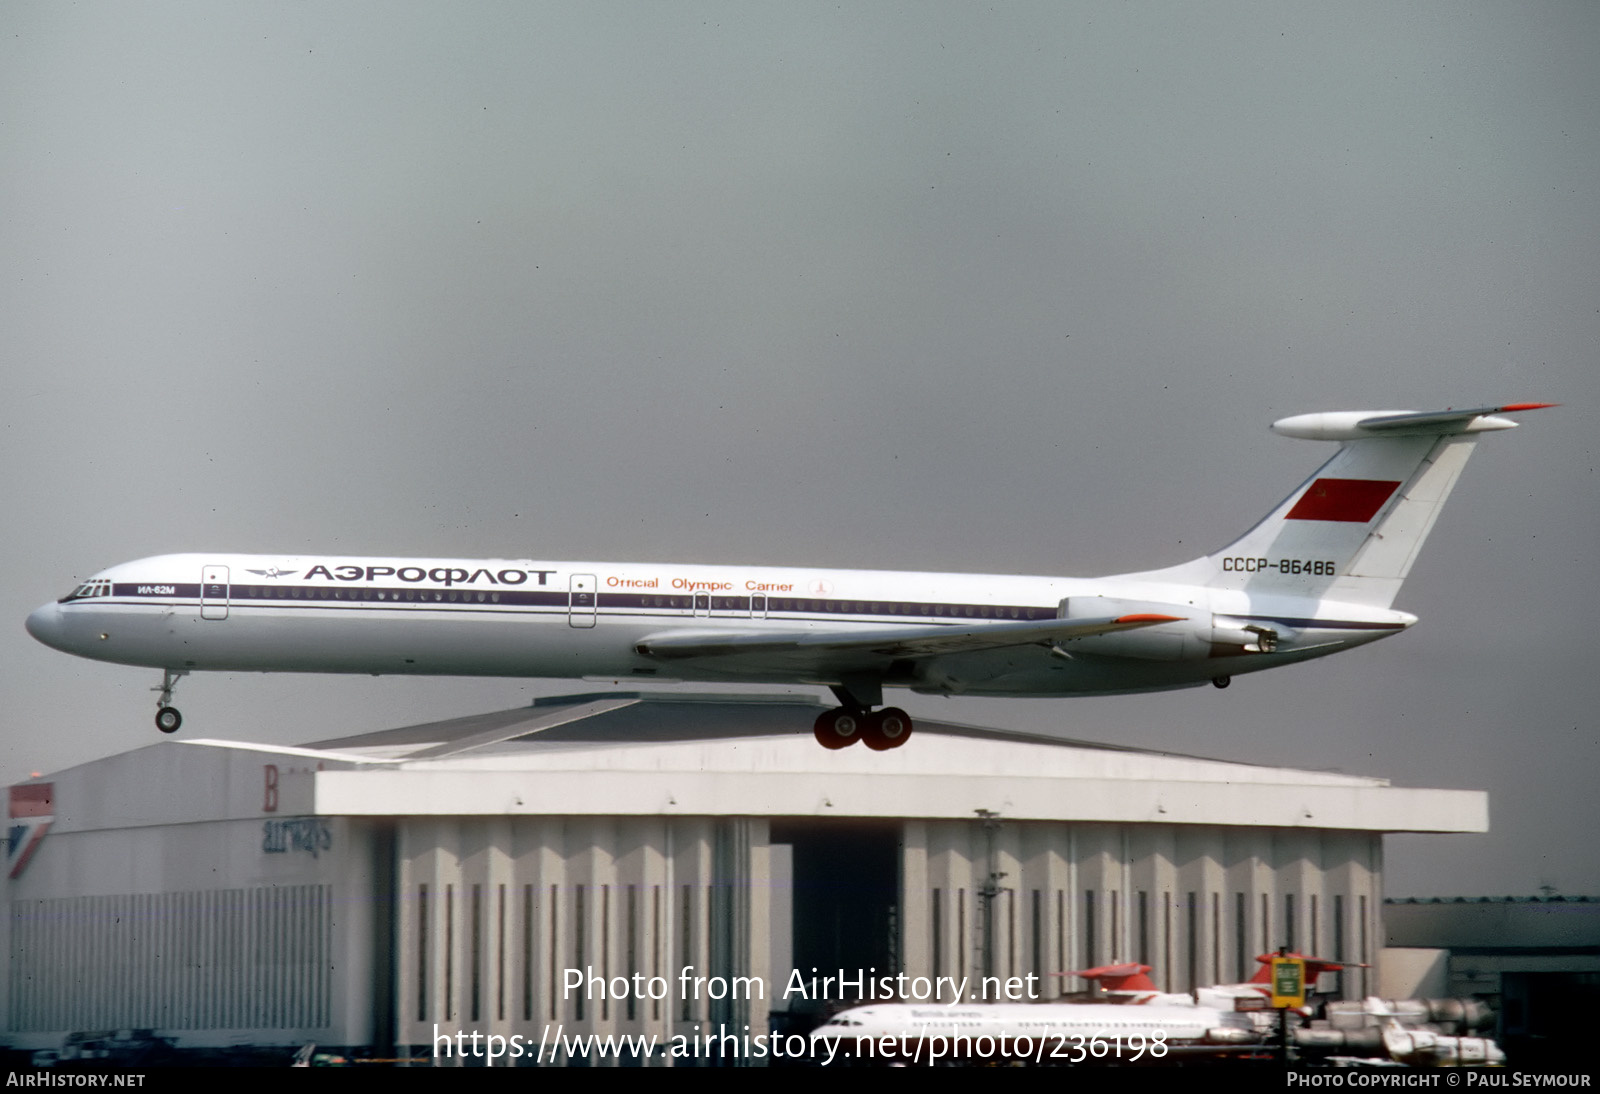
[27,403,1550,750]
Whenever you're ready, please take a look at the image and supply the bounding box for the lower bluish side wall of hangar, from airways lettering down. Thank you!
[6,817,393,1048]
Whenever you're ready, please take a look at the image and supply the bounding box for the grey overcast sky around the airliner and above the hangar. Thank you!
[0,0,1600,896]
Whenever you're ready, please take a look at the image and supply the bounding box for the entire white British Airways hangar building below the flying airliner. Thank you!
[3,693,1488,1064]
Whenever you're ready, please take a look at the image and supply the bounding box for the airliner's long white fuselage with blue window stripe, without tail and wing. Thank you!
[27,553,1413,696]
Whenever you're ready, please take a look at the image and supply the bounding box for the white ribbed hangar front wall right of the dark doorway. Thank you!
[904,821,1382,998]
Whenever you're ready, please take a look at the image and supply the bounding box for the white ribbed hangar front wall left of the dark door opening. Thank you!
[397,817,773,1051]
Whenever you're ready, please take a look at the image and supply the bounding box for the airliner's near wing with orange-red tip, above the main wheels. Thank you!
[634,614,1181,661]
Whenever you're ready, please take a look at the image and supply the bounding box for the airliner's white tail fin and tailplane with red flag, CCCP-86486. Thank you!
[1141,403,1554,608]
